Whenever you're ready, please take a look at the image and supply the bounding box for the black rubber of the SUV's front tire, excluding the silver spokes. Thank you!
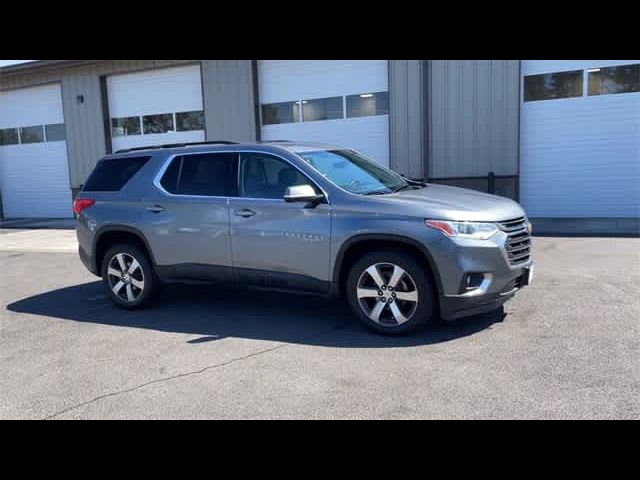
[345,251,435,335]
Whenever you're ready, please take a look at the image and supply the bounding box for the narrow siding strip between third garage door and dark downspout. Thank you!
[389,60,427,178]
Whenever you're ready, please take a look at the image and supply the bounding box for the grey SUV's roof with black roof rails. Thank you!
[106,140,344,158]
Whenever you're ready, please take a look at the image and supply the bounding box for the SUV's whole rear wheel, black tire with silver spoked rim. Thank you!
[101,243,158,310]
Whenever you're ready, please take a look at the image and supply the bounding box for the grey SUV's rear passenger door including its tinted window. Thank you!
[144,152,238,280]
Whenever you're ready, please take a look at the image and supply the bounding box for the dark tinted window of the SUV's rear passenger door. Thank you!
[175,153,238,197]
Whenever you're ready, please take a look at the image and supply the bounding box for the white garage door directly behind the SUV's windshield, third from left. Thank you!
[258,60,389,165]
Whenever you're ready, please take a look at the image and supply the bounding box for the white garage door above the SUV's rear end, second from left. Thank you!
[107,65,205,152]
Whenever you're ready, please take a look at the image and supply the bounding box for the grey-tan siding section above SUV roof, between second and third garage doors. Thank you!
[202,60,256,141]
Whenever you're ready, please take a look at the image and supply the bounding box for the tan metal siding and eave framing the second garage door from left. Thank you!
[0,60,255,190]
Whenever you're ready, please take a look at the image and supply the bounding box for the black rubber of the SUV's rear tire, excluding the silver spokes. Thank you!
[100,243,158,310]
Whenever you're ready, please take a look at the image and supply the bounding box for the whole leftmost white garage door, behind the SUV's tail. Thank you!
[0,85,73,218]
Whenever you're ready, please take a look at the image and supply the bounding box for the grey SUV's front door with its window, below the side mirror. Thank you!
[229,153,331,291]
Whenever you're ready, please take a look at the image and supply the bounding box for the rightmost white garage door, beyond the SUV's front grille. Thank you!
[520,60,640,218]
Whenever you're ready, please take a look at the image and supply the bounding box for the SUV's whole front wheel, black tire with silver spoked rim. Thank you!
[346,251,434,335]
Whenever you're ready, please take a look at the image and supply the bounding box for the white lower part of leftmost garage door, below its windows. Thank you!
[0,142,73,218]
